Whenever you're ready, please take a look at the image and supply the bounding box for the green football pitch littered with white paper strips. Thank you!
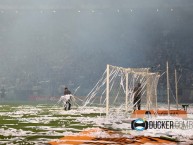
[0,104,193,145]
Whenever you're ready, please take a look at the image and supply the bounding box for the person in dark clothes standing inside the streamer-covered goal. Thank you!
[133,83,142,111]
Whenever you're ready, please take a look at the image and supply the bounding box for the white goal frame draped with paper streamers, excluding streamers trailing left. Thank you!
[106,64,159,115]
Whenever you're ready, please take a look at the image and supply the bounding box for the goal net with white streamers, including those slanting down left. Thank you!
[83,65,159,115]
